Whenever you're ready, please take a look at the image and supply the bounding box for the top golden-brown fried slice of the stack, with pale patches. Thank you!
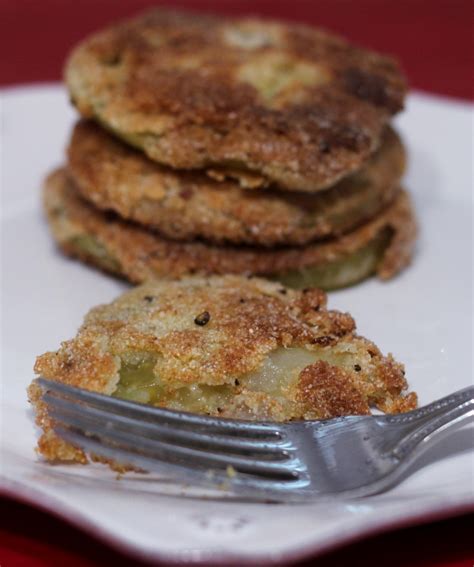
[65,9,406,192]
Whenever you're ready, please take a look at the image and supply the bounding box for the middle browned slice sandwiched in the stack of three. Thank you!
[68,121,405,246]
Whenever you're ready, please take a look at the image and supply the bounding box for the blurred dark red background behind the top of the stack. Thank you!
[0,0,474,98]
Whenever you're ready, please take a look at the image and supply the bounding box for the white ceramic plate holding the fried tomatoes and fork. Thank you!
[0,85,474,565]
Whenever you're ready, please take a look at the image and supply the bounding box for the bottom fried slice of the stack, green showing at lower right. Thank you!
[44,169,416,289]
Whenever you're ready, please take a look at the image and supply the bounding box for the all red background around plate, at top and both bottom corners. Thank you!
[0,0,474,567]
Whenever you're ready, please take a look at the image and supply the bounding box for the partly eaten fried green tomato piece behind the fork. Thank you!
[29,276,417,462]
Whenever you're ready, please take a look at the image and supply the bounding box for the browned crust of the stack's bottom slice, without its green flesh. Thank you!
[44,170,416,283]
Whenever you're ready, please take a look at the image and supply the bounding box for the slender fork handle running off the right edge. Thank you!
[392,386,474,460]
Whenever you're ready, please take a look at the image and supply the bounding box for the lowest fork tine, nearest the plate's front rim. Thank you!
[55,426,309,502]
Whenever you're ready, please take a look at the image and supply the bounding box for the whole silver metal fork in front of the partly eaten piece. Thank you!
[37,378,474,502]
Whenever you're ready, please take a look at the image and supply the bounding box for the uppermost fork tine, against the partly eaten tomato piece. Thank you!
[36,378,282,441]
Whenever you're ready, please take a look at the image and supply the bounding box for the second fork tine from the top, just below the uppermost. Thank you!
[43,394,292,460]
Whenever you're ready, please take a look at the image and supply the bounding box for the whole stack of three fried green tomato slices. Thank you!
[44,10,416,289]
